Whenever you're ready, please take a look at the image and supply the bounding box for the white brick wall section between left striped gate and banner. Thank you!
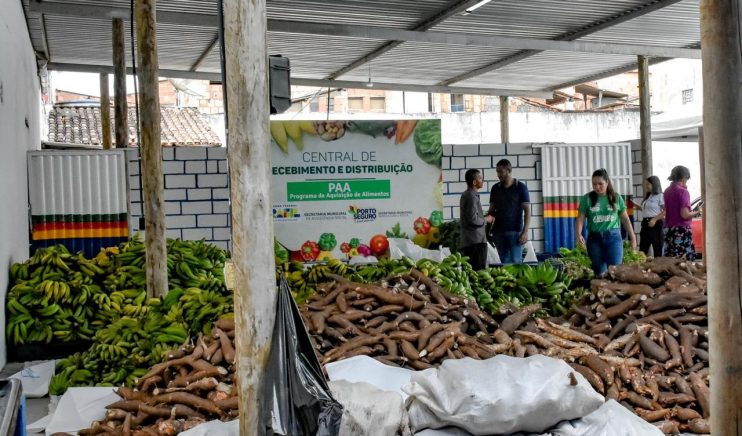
[128,147,231,249]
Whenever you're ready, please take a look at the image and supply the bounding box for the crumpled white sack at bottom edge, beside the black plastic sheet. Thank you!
[329,380,412,436]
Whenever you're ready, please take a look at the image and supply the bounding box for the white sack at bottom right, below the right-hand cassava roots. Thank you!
[551,400,663,436]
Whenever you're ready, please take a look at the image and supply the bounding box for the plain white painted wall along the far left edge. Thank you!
[0,0,41,367]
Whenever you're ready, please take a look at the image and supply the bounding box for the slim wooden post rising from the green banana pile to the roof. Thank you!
[134,0,167,297]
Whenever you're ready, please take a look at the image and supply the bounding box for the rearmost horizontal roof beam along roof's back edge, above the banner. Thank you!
[47,62,552,98]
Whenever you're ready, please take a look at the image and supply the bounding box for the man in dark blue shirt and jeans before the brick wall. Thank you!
[487,159,531,263]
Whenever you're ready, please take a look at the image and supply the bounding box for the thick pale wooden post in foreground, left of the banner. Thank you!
[224,0,278,435]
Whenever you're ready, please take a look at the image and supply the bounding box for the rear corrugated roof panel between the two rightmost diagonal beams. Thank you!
[455,51,636,90]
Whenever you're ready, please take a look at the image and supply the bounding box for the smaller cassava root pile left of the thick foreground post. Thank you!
[72,318,238,436]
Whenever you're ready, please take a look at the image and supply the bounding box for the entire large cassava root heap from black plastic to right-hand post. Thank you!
[302,258,710,434]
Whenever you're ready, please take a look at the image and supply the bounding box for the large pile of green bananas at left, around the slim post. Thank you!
[6,235,234,393]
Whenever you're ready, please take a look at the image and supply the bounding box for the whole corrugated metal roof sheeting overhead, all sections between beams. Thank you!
[22,0,699,94]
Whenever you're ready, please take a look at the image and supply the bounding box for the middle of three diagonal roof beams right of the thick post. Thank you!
[439,0,682,86]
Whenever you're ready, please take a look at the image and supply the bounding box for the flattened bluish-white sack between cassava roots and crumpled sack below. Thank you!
[325,356,415,401]
